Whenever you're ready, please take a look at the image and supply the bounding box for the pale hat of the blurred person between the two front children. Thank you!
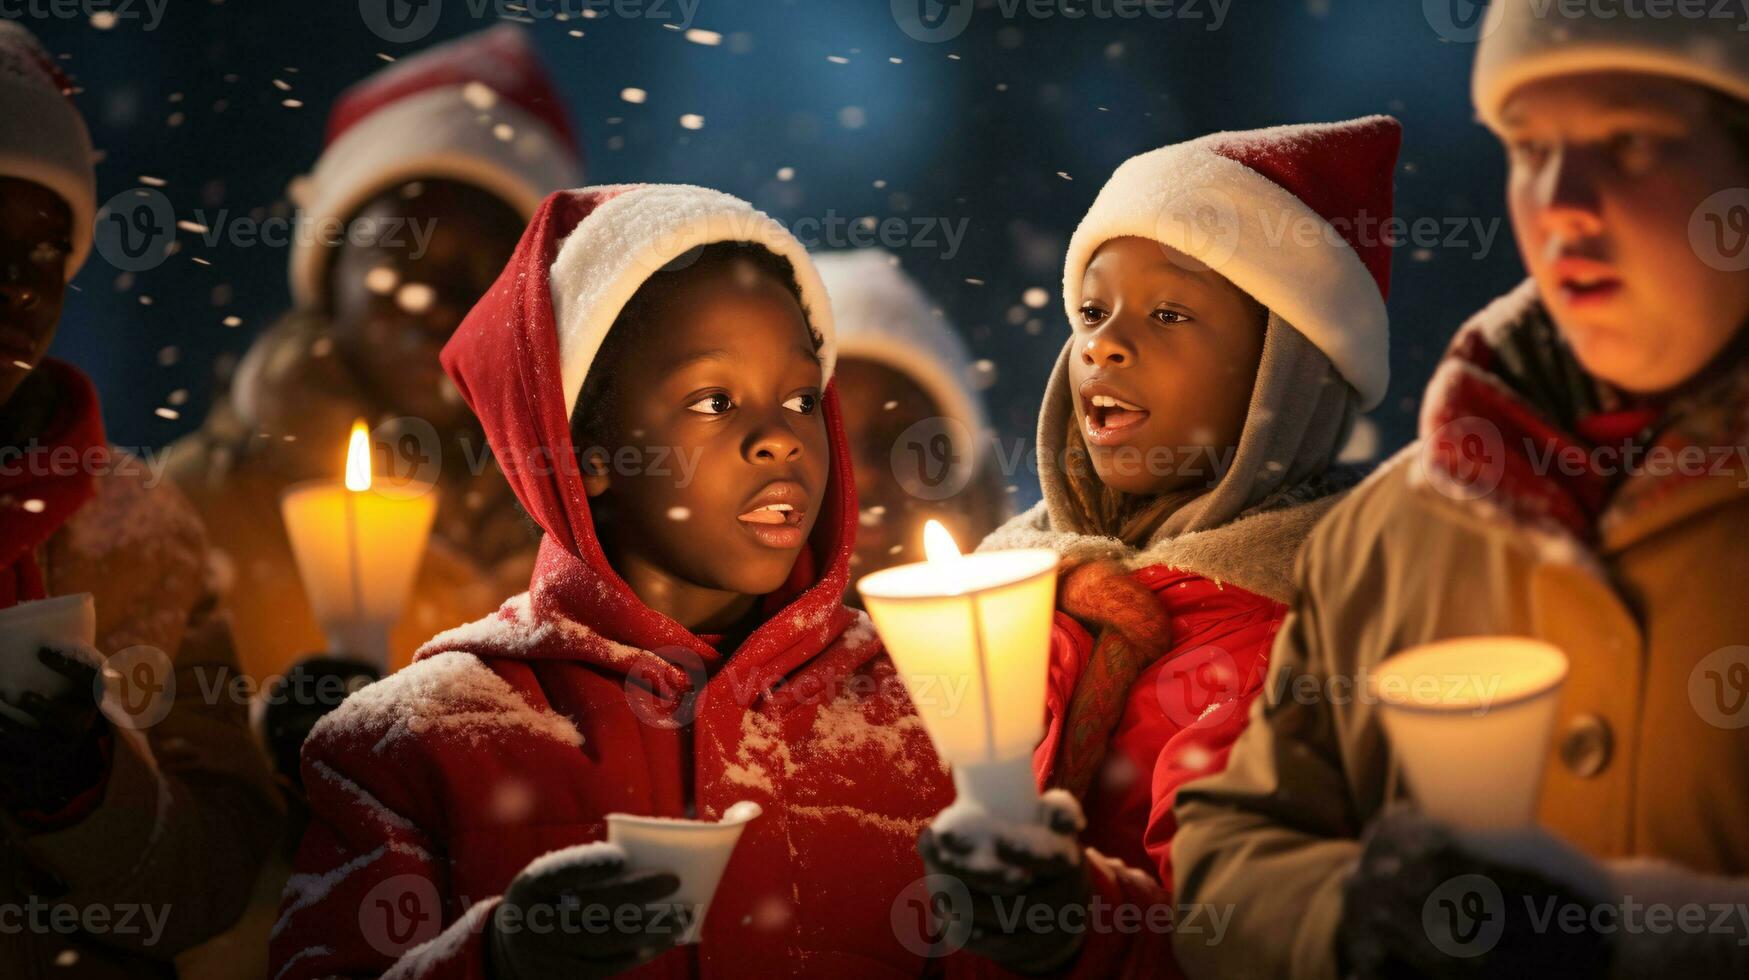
[813,249,986,469]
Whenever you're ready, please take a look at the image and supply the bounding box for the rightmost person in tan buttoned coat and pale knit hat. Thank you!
[1174,0,1749,977]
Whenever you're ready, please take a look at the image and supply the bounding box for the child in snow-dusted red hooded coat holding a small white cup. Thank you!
[271,186,1163,980]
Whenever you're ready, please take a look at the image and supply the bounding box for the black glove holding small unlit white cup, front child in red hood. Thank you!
[486,844,691,980]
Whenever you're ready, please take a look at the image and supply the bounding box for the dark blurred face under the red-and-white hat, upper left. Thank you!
[329,180,523,427]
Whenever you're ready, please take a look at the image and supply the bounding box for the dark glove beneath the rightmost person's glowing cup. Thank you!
[1336,810,1611,980]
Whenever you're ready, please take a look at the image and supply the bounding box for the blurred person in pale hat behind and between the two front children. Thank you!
[815,249,1007,604]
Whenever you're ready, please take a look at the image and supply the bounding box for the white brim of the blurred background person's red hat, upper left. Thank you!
[290,86,582,308]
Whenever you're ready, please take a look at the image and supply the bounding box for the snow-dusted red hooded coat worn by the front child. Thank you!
[273,191,1163,980]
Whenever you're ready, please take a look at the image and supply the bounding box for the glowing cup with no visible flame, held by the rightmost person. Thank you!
[1369,637,1567,830]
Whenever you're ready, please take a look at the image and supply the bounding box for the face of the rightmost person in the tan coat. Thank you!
[1502,72,1749,392]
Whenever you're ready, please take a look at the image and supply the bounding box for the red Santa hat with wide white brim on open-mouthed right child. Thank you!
[1063,116,1403,410]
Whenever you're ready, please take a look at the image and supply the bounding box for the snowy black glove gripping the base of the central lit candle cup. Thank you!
[916,789,1093,973]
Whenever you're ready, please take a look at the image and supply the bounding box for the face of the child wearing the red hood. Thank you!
[579,263,831,595]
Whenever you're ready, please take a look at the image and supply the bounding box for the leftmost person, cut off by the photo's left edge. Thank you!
[0,21,282,978]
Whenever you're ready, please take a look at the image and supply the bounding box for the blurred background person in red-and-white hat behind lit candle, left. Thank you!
[170,25,582,693]
